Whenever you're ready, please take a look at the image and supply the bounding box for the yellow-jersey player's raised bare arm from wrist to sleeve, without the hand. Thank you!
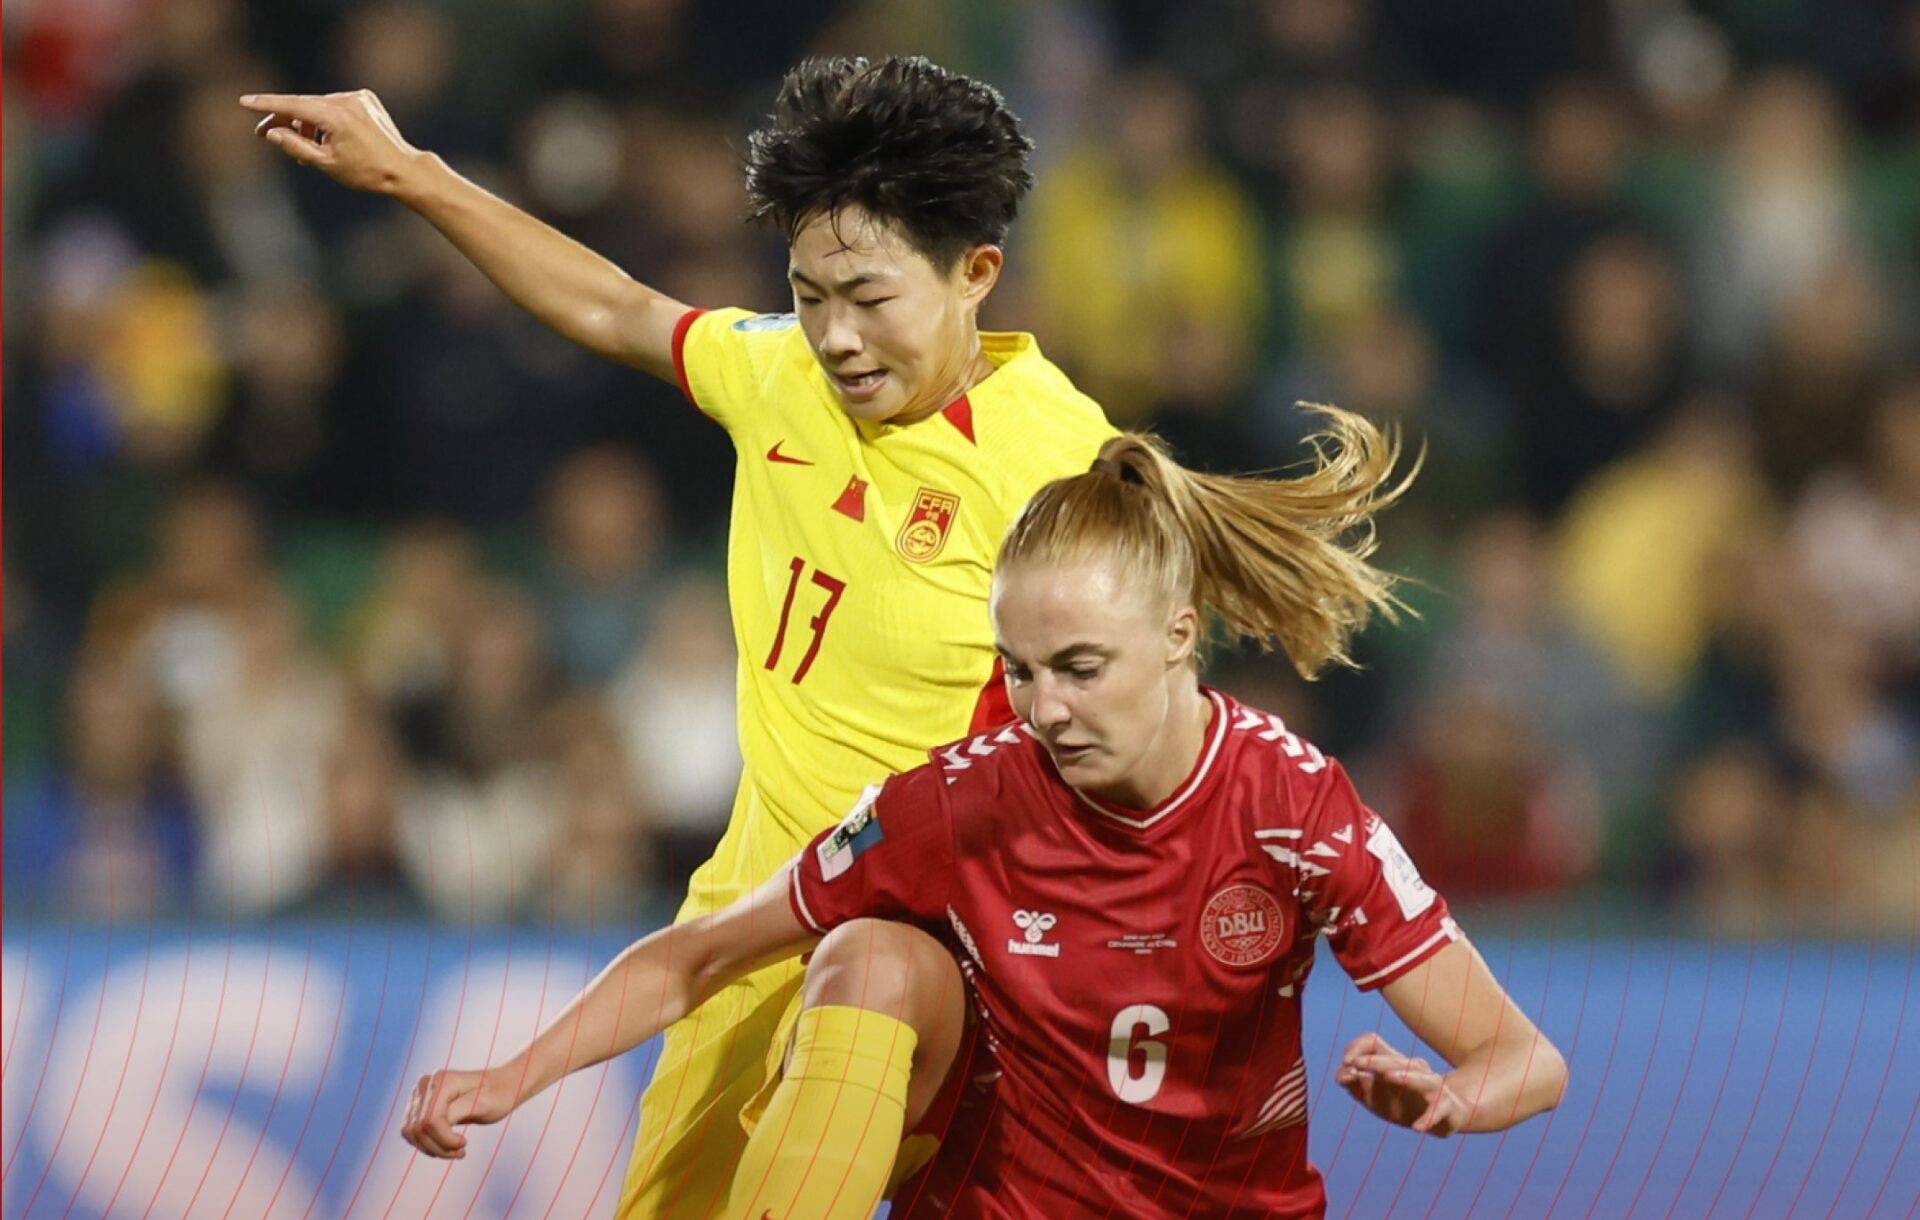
[390,152,684,377]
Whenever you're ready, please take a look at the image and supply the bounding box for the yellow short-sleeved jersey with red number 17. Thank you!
[674,309,1114,918]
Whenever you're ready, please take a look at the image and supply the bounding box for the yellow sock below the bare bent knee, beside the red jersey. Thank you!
[728,1007,920,1220]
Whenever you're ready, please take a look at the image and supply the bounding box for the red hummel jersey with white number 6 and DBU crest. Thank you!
[789,690,1459,1220]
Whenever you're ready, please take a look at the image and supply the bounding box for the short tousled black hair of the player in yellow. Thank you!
[747,56,1033,269]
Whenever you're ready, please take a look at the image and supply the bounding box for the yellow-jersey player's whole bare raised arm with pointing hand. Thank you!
[240,88,687,380]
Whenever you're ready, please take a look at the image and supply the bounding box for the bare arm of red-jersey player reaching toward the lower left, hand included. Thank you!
[399,865,820,1157]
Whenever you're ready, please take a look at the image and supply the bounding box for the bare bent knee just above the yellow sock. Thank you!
[804,918,960,1026]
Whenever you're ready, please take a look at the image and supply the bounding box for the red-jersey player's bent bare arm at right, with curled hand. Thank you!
[1334,939,1567,1135]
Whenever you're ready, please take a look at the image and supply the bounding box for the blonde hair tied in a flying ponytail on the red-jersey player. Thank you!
[998,403,1419,678]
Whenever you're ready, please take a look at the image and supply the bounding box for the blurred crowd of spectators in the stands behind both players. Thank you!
[4,0,1920,936]
